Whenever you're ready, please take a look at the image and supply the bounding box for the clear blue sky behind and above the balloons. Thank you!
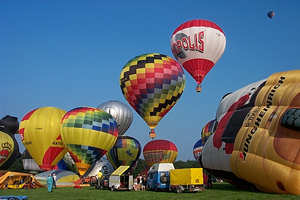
[0,0,300,160]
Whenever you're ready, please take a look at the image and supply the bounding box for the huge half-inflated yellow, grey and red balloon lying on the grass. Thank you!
[201,70,300,194]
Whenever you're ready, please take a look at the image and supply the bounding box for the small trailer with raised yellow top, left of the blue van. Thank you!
[108,166,133,191]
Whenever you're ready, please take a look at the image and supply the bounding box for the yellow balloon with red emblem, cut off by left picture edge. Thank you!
[0,131,20,170]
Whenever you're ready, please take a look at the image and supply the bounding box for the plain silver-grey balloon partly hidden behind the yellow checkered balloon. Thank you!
[98,100,133,135]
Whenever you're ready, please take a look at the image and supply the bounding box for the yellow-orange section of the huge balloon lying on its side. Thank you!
[231,70,300,195]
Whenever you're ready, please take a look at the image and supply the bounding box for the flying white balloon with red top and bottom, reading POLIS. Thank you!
[171,19,226,92]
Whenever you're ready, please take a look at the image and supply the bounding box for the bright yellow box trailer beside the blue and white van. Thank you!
[170,168,204,193]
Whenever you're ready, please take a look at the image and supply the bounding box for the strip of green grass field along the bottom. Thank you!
[0,184,300,200]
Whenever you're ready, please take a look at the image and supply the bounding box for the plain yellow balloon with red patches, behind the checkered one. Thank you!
[19,107,66,170]
